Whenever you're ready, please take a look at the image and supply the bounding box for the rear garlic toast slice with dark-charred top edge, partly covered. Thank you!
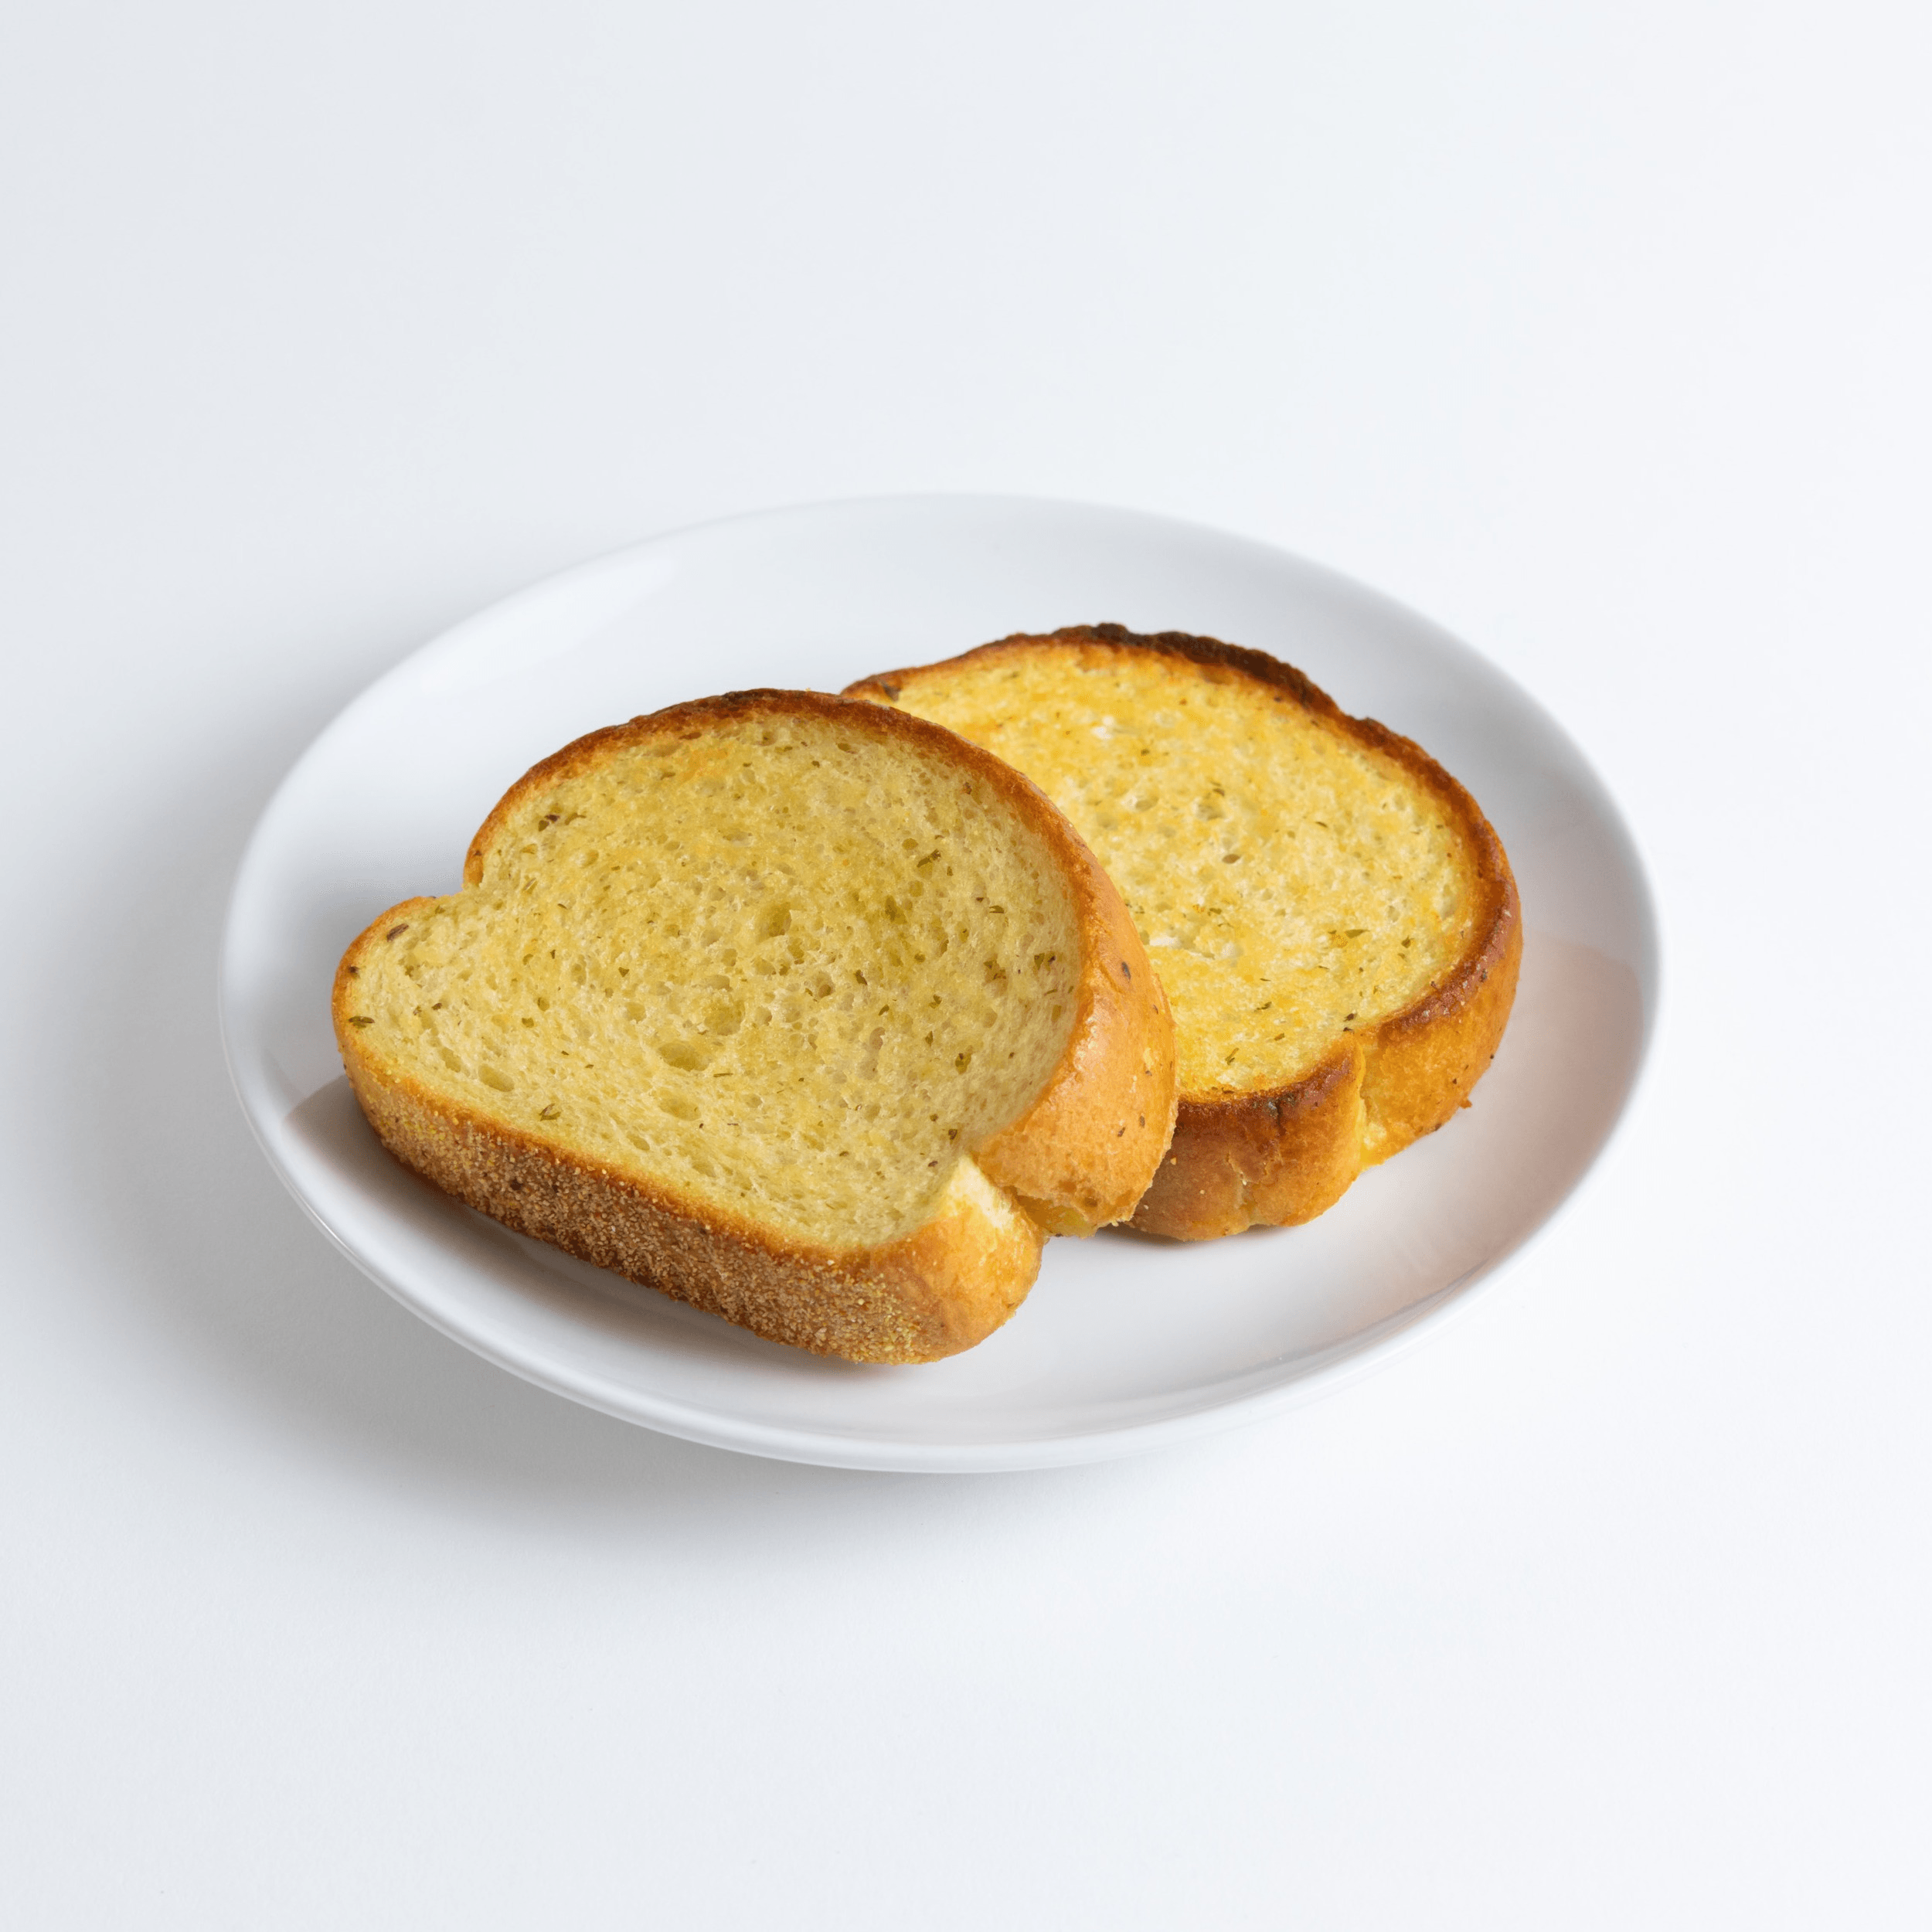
[849,624,1522,1240]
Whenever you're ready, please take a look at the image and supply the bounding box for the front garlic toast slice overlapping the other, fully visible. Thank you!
[335,692,1175,1362]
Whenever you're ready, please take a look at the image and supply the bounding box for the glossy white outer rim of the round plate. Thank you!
[215,491,1665,1475]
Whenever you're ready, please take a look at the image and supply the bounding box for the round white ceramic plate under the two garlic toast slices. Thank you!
[223,498,1656,1471]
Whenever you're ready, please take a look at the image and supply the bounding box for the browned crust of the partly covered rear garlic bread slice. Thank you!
[846,624,1522,1240]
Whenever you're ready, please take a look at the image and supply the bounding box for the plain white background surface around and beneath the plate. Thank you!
[0,0,1932,1928]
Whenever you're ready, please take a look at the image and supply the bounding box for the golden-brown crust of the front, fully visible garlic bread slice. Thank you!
[331,690,1177,1362]
